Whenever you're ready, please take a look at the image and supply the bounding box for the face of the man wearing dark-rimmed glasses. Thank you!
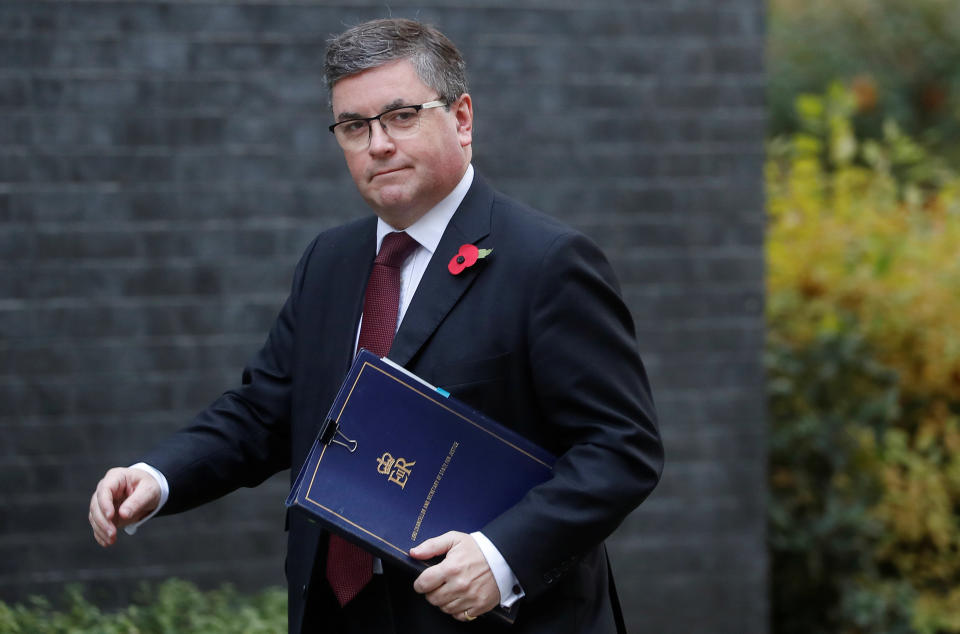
[332,60,473,229]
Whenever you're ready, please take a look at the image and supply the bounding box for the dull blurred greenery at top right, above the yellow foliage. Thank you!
[767,0,960,165]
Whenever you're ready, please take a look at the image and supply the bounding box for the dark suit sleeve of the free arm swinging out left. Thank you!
[142,235,315,514]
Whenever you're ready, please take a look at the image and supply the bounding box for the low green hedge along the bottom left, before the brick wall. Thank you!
[0,579,287,634]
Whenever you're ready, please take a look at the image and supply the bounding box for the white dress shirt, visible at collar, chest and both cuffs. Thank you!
[124,165,524,607]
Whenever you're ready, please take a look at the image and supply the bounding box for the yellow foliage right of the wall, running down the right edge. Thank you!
[766,82,960,633]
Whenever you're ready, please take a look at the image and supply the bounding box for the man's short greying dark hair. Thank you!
[323,18,467,104]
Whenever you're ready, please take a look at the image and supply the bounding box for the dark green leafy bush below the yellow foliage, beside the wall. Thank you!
[766,329,913,634]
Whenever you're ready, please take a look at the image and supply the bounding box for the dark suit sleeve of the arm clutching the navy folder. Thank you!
[483,233,663,598]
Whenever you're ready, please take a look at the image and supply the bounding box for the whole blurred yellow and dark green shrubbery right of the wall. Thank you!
[766,75,960,634]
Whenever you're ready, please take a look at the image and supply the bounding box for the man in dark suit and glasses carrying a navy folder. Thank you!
[90,20,663,634]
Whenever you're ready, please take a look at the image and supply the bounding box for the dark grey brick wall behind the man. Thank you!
[0,0,767,634]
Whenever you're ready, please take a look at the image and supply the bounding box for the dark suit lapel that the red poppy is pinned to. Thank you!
[389,174,493,365]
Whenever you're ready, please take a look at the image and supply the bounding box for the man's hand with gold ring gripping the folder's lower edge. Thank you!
[410,531,500,621]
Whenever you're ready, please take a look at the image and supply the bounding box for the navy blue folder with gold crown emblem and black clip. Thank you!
[286,350,555,621]
